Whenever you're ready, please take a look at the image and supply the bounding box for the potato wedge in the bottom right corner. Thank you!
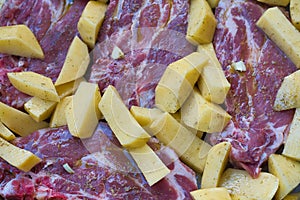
[268,154,300,200]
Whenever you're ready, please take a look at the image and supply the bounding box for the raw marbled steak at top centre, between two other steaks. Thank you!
[90,0,195,107]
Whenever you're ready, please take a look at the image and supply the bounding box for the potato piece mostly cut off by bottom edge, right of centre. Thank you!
[190,187,231,200]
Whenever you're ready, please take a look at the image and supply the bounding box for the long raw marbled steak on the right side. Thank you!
[213,0,296,177]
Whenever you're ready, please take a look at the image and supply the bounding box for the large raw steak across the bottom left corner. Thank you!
[0,122,197,200]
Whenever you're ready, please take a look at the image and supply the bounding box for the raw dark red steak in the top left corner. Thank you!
[0,0,88,108]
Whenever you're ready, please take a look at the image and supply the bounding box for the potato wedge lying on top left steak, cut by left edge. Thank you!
[0,24,44,59]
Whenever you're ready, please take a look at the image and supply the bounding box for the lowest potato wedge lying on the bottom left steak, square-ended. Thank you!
[129,144,170,186]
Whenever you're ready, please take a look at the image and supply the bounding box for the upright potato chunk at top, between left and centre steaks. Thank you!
[77,1,107,48]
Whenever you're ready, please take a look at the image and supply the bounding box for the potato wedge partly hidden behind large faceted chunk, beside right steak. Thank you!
[197,43,230,104]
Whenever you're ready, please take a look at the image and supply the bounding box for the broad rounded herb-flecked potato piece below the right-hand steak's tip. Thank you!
[219,168,279,200]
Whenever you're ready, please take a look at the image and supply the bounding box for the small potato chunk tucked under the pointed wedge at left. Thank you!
[24,97,57,122]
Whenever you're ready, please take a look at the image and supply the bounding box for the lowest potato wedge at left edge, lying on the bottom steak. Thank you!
[0,138,42,172]
